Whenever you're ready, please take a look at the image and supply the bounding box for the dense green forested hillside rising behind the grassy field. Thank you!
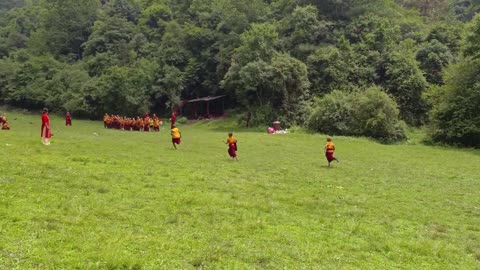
[0,0,480,146]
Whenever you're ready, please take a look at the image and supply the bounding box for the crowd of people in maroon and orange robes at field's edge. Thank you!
[103,114,163,131]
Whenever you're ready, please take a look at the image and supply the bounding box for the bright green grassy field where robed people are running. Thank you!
[0,114,480,269]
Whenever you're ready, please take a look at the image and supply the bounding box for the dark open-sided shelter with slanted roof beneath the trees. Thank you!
[182,95,225,119]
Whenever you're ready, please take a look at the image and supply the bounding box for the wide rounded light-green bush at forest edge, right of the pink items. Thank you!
[308,87,406,142]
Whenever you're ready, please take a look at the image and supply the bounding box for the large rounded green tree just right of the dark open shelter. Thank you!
[223,54,310,127]
